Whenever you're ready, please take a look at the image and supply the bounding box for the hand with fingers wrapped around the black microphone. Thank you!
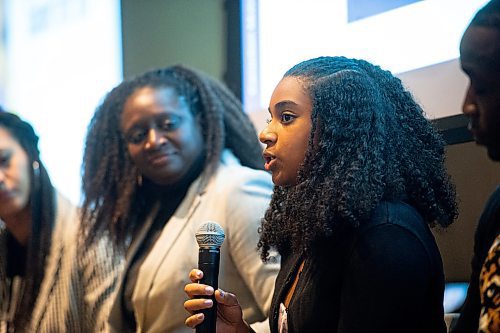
[184,269,250,333]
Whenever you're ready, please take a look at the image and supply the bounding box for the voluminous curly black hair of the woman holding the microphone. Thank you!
[258,57,457,260]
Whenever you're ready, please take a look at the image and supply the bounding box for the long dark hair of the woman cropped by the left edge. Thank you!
[0,107,57,331]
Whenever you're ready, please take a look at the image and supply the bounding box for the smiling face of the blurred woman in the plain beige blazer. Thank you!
[121,86,204,185]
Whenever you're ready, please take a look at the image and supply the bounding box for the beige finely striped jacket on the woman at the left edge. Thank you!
[0,195,123,333]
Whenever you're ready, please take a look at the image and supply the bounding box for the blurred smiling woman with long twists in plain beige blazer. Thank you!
[83,66,279,332]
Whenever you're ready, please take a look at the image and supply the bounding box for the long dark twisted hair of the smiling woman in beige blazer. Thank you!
[82,65,263,242]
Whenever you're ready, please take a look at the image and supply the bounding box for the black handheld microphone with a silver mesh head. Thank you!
[195,221,225,333]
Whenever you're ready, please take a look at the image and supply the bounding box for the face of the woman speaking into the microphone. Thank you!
[259,77,312,186]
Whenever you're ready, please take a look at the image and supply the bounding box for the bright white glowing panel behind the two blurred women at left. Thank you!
[5,0,122,203]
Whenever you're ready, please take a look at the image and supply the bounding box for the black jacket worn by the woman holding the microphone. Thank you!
[270,202,446,333]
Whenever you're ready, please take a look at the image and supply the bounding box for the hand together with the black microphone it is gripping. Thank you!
[184,221,249,333]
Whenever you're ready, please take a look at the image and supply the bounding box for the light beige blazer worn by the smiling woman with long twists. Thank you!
[110,151,279,333]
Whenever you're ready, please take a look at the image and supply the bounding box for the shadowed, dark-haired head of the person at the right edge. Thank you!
[460,25,500,161]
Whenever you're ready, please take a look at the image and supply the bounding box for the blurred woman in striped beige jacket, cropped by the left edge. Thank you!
[0,110,116,332]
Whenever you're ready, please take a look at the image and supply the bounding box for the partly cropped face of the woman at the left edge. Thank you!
[0,126,30,220]
